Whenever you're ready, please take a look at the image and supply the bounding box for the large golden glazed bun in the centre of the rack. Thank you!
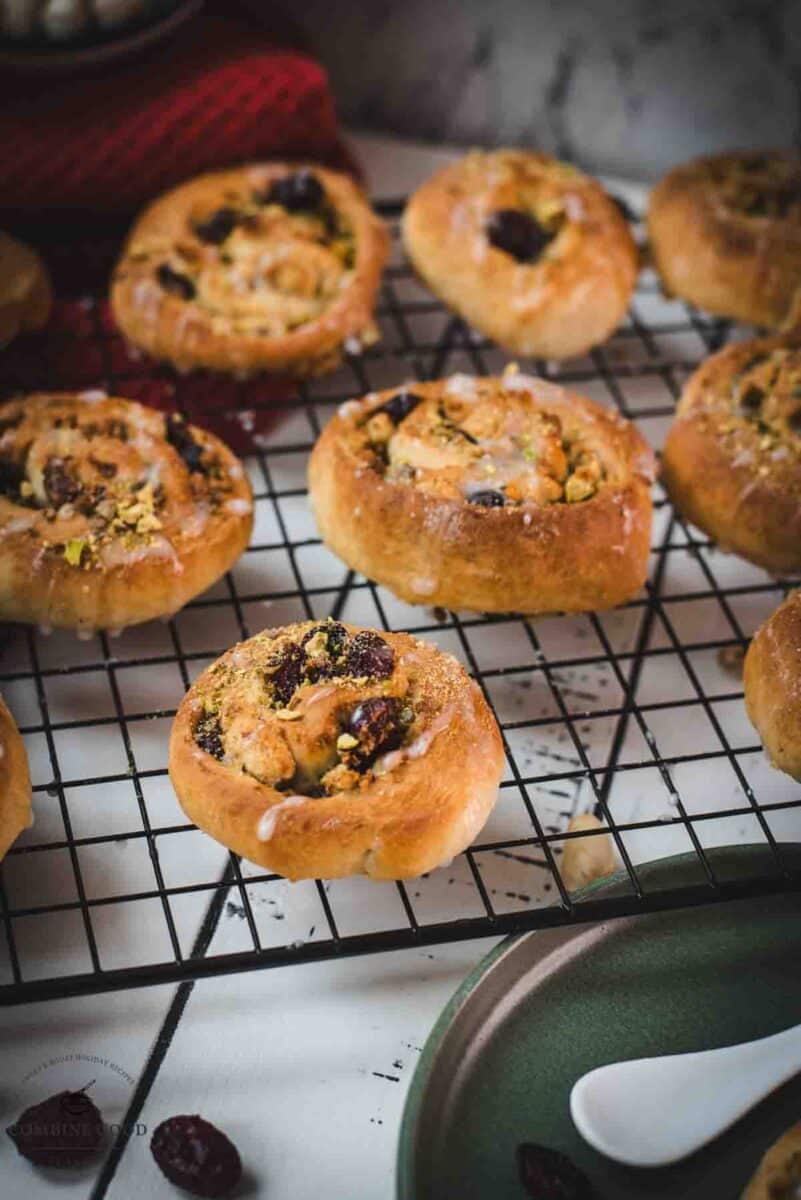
[309,367,655,613]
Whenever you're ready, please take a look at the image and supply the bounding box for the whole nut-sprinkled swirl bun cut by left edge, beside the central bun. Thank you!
[0,392,253,630]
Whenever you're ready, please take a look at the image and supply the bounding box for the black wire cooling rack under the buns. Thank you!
[0,204,801,1004]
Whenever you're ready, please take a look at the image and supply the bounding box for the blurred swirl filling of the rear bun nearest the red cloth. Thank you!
[127,170,356,336]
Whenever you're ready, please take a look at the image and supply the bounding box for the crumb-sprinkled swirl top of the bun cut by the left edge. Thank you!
[0,400,236,570]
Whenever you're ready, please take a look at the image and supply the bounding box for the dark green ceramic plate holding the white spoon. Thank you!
[398,847,801,1200]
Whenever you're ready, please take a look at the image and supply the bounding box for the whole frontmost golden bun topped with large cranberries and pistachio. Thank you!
[169,619,504,880]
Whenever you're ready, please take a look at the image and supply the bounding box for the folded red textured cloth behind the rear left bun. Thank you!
[0,14,343,215]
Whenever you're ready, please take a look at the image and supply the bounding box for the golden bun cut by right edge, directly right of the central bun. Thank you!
[662,336,801,574]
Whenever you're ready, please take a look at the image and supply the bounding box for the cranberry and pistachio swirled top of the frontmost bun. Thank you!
[192,618,424,797]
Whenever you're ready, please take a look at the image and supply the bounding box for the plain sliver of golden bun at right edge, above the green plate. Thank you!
[742,592,801,780]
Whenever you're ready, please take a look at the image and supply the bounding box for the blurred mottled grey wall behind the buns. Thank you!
[276,0,801,178]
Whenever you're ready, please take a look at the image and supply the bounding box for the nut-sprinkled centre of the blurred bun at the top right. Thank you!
[709,155,801,223]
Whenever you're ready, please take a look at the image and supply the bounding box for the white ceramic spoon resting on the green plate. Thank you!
[570,1025,801,1166]
